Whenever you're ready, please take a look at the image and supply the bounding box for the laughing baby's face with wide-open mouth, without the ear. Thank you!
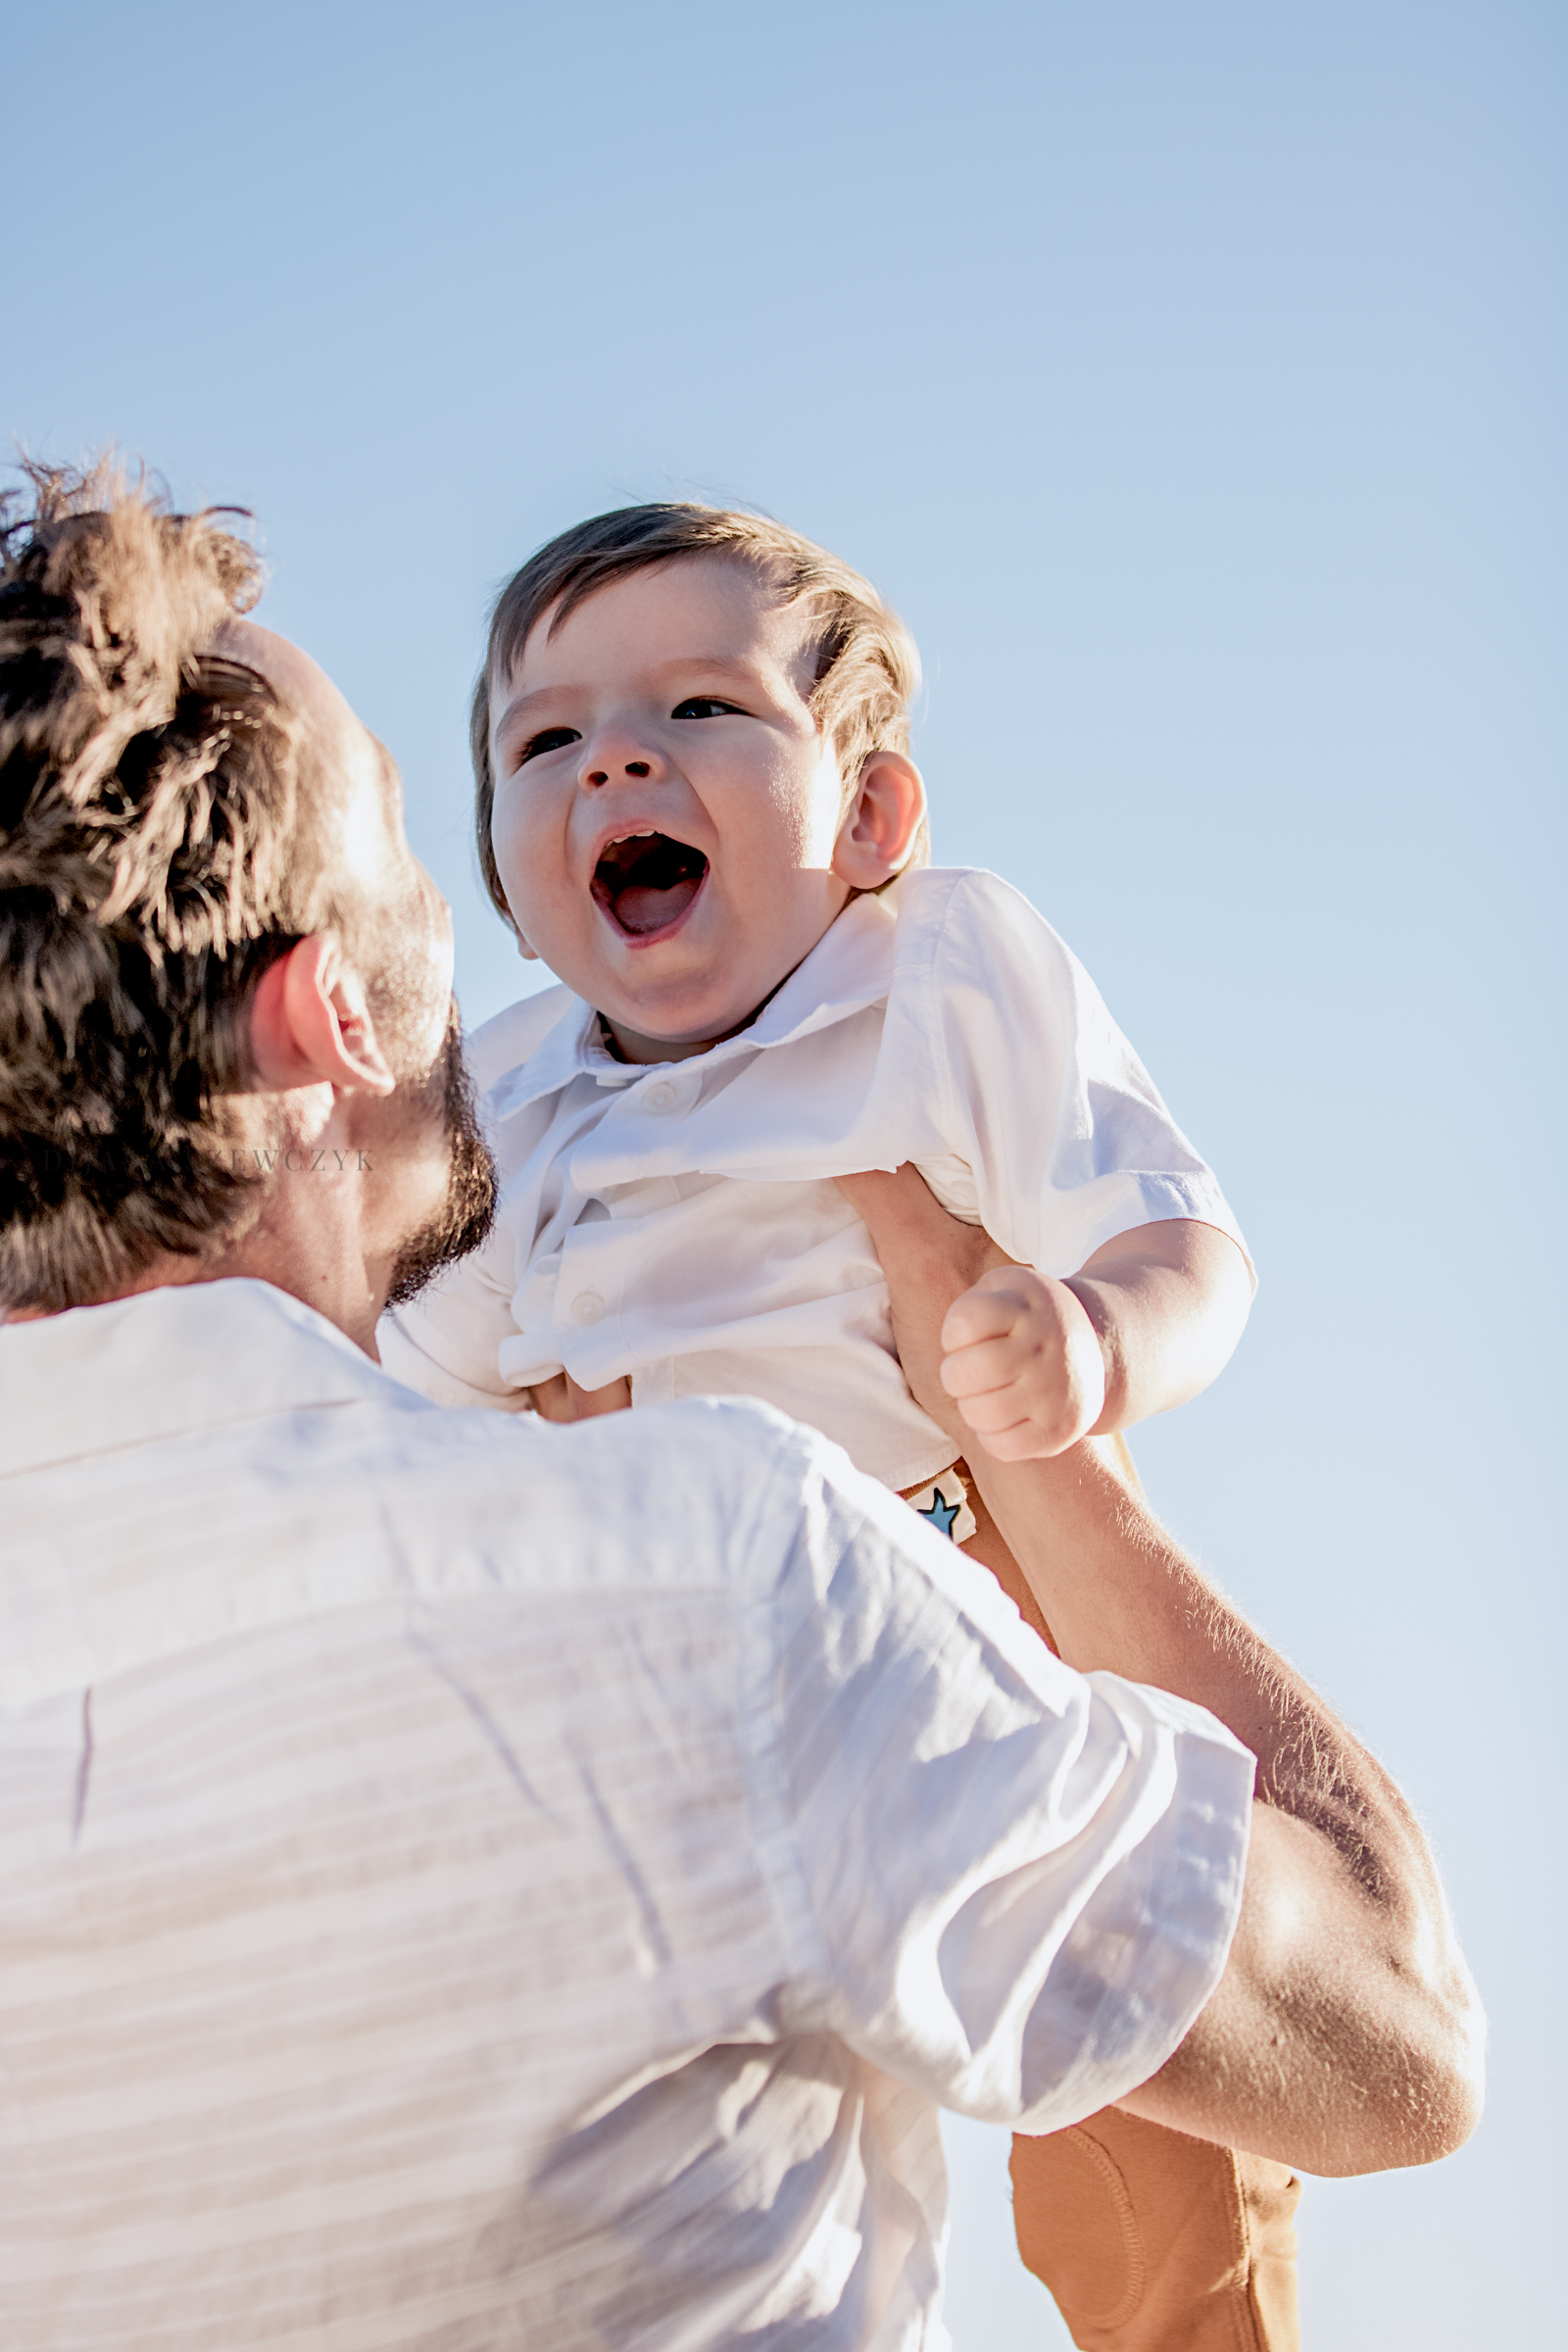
[491,555,849,1060]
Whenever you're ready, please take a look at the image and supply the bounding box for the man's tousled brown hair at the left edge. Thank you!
[0,466,313,1310]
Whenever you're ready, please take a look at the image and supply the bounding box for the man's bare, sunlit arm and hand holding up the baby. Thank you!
[842,1169,1484,2174]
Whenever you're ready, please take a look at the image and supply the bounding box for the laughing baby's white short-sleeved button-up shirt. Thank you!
[381,868,1246,1489]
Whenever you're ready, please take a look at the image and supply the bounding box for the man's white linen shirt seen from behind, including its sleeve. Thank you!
[0,1282,1250,2352]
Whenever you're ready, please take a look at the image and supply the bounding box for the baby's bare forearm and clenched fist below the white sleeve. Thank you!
[943,1218,1253,1463]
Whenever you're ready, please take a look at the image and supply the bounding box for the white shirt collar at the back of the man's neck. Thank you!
[0,1277,393,1477]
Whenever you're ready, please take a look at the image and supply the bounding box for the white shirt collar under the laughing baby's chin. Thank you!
[487,882,898,1119]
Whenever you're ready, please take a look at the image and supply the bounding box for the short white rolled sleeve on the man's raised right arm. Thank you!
[780,1448,1253,2131]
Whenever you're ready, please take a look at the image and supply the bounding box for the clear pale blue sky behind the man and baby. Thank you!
[0,0,1568,2352]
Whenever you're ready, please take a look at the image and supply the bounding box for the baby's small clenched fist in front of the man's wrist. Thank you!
[943,1265,1104,1463]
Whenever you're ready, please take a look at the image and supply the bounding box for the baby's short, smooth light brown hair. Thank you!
[467,506,926,922]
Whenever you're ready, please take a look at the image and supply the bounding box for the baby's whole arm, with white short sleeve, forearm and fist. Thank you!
[911,872,1253,1460]
